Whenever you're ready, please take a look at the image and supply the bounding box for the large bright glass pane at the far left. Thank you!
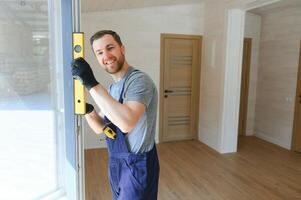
[0,0,63,200]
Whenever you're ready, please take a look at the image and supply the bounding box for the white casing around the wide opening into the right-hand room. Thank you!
[220,0,280,153]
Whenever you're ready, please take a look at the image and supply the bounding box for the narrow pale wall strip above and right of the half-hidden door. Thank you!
[244,12,261,135]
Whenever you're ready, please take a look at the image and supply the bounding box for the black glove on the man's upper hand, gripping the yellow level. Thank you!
[71,57,99,90]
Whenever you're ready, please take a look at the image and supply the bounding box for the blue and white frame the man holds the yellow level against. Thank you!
[58,0,85,200]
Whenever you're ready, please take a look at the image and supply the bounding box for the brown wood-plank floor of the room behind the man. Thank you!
[85,137,301,200]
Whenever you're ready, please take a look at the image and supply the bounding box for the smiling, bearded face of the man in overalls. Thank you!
[92,34,125,74]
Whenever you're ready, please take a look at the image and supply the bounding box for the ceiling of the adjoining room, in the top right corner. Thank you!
[250,0,301,15]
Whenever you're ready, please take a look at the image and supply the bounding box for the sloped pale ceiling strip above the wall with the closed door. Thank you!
[81,0,204,12]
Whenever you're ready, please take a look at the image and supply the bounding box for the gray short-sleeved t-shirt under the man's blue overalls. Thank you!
[109,66,158,153]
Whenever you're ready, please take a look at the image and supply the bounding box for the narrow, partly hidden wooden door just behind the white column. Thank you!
[238,38,252,135]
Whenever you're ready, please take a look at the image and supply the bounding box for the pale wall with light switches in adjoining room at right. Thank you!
[251,6,301,149]
